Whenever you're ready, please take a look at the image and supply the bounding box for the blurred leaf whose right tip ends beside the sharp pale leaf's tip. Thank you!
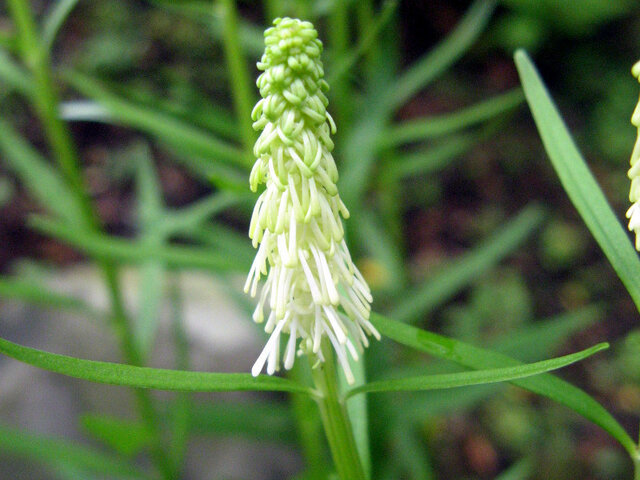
[378,88,524,149]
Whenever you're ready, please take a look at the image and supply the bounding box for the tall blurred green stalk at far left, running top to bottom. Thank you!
[8,0,174,480]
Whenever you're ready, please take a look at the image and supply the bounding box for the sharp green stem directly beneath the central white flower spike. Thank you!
[311,340,366,480]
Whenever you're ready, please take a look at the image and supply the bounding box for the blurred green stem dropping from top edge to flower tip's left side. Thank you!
[218,0,255,165]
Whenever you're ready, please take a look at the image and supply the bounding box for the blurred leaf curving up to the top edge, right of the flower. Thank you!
[385,0,496,110]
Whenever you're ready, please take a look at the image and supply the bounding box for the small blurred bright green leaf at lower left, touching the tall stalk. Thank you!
[80,413,153,457]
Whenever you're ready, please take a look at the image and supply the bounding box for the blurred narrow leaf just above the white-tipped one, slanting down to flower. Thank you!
[65,71,246,167]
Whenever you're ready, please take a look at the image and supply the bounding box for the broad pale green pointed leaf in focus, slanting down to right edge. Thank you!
[515,50,640,310]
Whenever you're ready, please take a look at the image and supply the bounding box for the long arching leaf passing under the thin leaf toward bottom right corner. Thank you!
[371,313,636,455]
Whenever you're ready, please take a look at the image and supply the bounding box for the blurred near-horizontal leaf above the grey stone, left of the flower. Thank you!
[31,217,250,271]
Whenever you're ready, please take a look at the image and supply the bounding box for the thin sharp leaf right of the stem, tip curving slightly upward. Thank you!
[347,343,609,397]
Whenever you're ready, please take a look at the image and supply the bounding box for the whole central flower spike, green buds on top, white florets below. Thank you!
[245,18,380,383]
